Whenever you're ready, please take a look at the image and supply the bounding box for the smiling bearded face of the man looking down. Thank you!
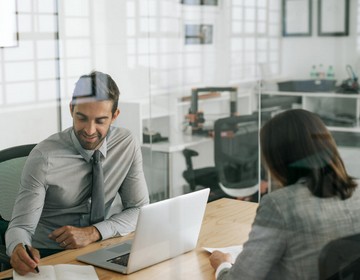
[70,100,119,150]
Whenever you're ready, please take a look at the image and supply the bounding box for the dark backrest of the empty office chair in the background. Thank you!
[214,115,259,192]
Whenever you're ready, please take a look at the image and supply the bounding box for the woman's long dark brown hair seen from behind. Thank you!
[260,109,357,199]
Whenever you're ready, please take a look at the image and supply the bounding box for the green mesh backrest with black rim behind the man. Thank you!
[0,144,36,220]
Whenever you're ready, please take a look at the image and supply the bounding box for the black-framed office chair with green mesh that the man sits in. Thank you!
[0,144,36,271]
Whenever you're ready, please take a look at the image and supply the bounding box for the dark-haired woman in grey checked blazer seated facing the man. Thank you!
[210,109,360,280]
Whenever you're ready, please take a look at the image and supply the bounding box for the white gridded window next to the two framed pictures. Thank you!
[230,0,281,82]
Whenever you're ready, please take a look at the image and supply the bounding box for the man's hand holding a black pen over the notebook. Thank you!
[10,243,40,275]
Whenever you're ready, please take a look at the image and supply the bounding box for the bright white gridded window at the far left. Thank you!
[0,0,59,107]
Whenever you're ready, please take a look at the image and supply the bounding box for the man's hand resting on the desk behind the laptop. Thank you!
[49,226,101,249]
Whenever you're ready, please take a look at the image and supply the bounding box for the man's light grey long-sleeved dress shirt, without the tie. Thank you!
[6,127,149,255]
